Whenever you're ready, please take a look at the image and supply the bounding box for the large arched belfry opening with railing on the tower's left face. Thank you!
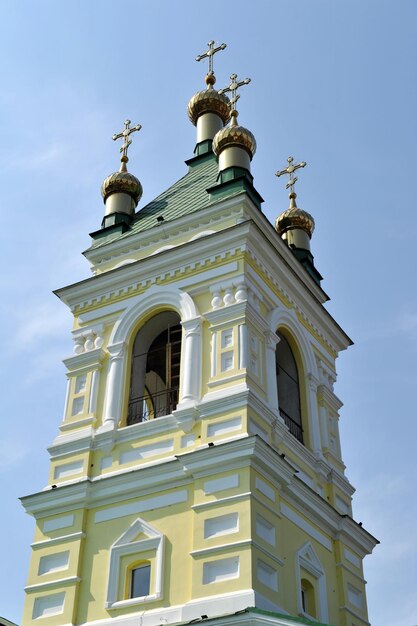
[127,311,182,425]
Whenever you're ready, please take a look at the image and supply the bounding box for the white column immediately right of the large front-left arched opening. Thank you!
[181,317,201,403]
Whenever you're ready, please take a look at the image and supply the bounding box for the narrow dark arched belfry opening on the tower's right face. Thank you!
[276,331,303,443]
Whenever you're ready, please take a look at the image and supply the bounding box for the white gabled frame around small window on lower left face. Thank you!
[105,518,164,609]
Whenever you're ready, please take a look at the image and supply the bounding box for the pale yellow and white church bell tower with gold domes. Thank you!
[22,42,377,626]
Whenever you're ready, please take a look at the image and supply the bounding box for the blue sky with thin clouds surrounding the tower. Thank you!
[0,0,417,626]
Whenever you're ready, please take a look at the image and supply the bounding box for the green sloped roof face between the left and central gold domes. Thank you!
[91,152,218,249]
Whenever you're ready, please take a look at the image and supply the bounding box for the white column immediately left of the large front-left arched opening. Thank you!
[102,342,126,430]
